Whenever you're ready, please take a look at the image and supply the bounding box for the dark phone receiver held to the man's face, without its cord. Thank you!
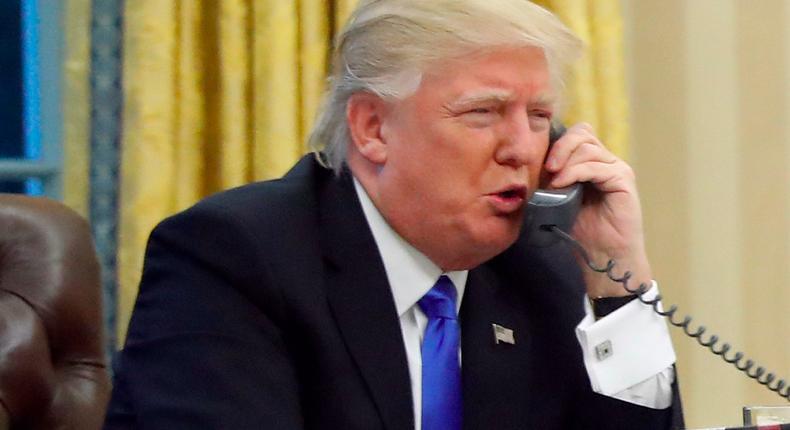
[524,124,583,247]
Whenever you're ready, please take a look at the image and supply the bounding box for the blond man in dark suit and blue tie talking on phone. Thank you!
[106,0,682,430]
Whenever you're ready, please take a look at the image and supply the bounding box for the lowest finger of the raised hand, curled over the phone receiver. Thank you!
[550,161,635,192]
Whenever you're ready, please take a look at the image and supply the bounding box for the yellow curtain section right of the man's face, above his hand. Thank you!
[536,0,628,159]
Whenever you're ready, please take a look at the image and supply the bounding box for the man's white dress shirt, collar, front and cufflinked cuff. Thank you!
[354,178,675,430]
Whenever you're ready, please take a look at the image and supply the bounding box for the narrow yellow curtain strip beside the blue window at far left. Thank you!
[63,0,91,217]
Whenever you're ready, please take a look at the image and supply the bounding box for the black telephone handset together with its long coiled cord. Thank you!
[525,124,790,401]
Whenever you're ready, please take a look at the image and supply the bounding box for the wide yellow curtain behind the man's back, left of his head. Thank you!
[117,0,356,341]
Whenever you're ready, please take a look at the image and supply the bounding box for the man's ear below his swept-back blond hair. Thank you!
[346,92,388,164]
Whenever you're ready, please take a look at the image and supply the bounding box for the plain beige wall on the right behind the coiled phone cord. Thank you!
[624,0,790,428]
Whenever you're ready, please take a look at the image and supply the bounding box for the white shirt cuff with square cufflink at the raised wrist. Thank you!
[576,281,676,404]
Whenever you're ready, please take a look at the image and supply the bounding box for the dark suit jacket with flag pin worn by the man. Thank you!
[105,156,679,430]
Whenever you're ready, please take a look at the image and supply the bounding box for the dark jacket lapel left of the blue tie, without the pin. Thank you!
[320,172,414,429]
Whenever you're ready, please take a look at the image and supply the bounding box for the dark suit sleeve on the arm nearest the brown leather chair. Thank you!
[105,203,302,429]
